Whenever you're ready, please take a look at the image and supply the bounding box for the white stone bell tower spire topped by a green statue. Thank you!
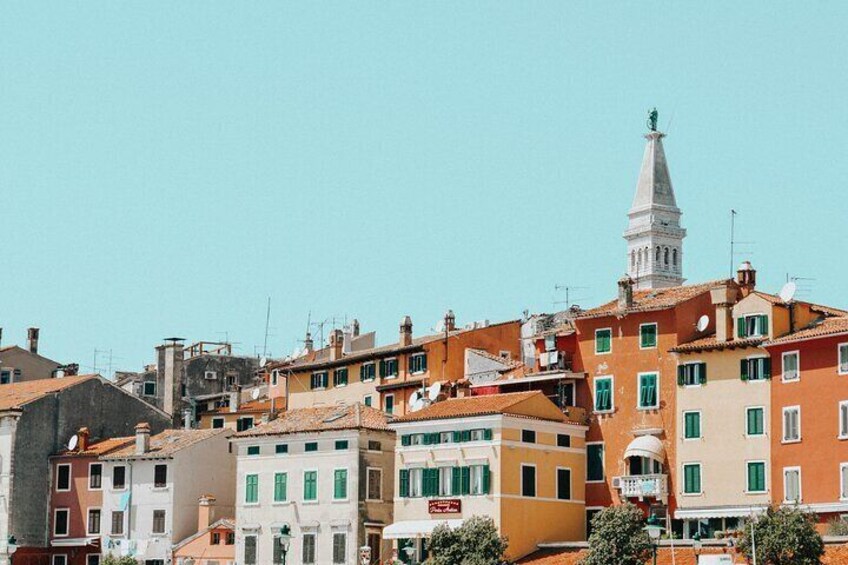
[624,109,686,289]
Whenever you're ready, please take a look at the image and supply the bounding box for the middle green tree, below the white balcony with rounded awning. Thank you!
[582,503,651,565]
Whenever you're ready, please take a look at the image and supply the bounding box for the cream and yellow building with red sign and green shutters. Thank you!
[383,391,586,562]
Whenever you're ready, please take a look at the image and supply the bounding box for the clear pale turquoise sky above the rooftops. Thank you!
[0,4,848,373]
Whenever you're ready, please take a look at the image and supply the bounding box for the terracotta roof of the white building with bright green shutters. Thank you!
[233,402,389,438]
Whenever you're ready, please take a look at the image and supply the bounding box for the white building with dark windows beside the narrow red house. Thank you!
[101,424,235,565]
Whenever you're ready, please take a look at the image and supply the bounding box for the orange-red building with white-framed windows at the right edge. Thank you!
[764,317,848,523]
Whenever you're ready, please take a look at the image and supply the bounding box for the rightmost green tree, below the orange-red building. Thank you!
[739,506,824,565]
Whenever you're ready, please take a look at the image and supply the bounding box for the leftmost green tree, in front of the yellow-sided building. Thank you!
[426,516,508,565]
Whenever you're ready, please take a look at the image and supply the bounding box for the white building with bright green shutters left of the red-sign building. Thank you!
[231,403,395,565]
